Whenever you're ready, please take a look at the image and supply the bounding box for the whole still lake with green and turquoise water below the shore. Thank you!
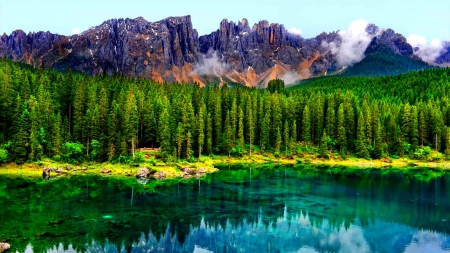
[0,167,450,253]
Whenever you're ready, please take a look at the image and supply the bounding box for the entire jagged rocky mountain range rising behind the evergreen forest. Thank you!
[0,16,442,86]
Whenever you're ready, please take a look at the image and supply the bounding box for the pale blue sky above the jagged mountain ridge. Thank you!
[0,0,450,44]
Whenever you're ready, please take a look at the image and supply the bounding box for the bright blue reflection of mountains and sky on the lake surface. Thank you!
[25,209,450,253]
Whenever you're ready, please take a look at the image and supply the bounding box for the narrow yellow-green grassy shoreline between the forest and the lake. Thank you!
[0,151,450,179]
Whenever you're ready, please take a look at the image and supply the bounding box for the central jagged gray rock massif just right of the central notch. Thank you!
[199,19,340,75]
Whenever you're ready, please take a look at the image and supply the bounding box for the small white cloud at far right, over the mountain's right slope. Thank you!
[407,34,443,64]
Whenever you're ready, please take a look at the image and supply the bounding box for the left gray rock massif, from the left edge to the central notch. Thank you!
[0,16,201,82]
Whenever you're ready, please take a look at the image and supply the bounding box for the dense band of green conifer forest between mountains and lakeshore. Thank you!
[0,60,450,163]
